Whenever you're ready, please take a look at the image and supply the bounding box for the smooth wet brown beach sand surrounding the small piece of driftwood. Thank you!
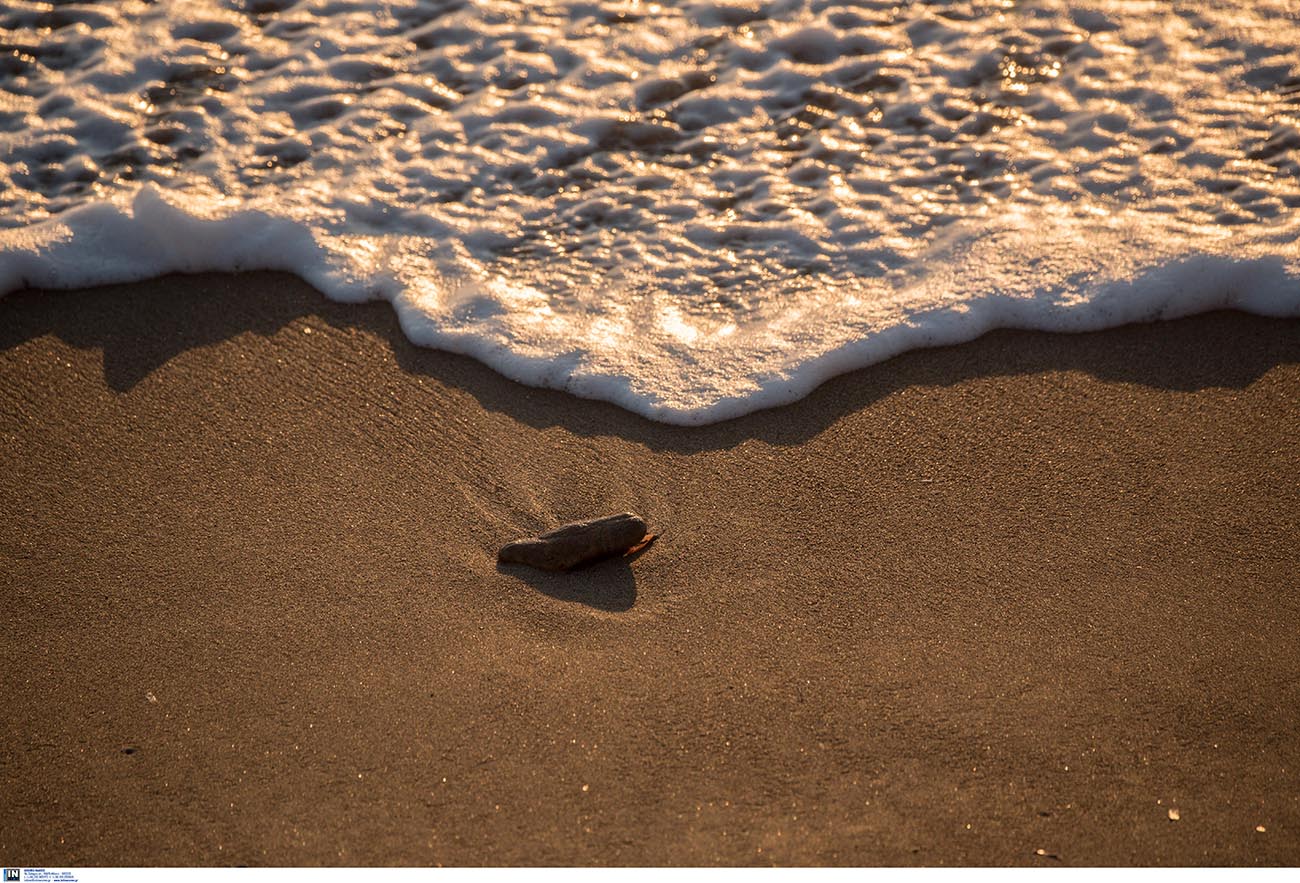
[0,274,1300,866]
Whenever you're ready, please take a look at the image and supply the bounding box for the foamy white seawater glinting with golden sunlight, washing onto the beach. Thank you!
[0,0,1300,423]
